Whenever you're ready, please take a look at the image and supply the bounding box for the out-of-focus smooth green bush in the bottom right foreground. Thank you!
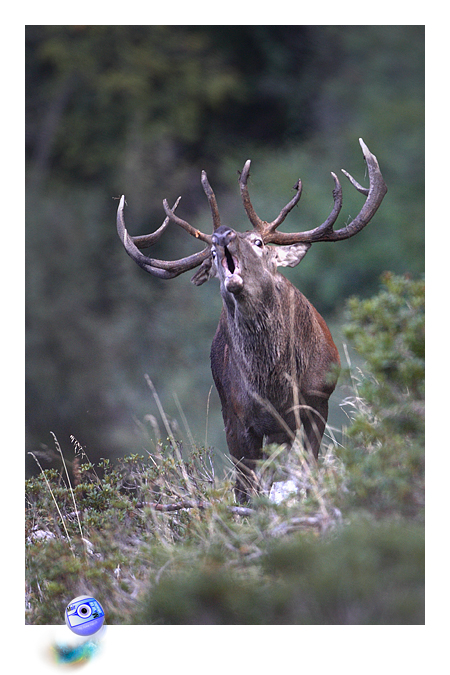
[135,521,424,624]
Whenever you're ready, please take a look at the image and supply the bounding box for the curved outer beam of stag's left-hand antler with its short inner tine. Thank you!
[117,195,210,279]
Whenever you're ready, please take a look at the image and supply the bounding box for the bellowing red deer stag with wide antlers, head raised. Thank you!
[117,139,387,501]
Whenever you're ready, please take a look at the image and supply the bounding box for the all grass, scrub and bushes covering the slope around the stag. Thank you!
[26,276,424,624]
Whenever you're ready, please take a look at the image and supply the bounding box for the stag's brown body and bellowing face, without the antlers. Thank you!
[211,227,339,501]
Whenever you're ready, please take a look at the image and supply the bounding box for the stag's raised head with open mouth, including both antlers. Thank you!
[117,139,387,298]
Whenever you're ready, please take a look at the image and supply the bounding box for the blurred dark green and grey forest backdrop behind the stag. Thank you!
[26,26,424,472]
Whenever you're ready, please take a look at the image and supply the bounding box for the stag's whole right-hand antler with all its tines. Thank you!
[239,138,387,244]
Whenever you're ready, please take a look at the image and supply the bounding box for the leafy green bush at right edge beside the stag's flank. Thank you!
[339,274,425,516]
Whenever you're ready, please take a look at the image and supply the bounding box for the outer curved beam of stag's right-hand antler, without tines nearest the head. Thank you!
[266,138,387,244]
